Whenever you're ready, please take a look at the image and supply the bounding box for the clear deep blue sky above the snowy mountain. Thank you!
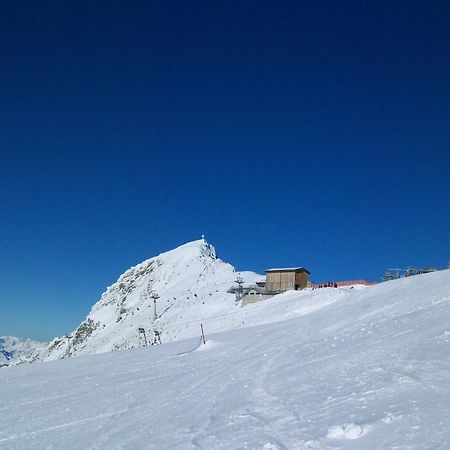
[0,0,450,339]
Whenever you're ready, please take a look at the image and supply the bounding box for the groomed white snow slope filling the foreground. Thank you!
[0,270,450,450]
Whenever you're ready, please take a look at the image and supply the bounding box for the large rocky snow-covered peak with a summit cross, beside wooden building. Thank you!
[42,239,261,360]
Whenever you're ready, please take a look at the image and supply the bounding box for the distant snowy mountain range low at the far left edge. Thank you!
[0,336,46,367]
